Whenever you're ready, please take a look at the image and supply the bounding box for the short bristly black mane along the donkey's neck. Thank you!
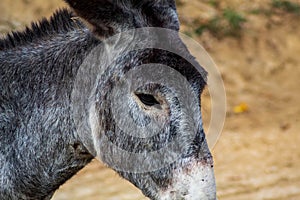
[0,8,83,50]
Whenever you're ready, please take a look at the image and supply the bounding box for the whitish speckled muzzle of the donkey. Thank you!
[159,160,216,200]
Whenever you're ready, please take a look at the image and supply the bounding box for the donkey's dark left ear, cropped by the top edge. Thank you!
[65,0,128,38]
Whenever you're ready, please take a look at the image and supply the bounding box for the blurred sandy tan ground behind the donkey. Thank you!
[0,0,300,200]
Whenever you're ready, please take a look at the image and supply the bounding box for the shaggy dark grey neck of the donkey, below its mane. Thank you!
[0,11,98,200]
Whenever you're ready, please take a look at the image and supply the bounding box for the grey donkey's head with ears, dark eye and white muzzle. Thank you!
[66,0,216,199]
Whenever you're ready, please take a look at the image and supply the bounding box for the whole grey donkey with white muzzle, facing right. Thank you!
[0,0,216,200]
